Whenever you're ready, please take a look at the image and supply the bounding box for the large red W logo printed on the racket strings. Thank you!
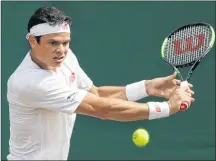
[173,34,205,55]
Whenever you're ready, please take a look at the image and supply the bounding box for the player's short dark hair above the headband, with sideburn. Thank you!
[28,7,71,43]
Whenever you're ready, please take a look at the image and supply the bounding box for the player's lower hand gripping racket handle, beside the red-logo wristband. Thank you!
[168,86,195,115]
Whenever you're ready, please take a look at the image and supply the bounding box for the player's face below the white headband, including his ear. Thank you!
[31,33,70,68]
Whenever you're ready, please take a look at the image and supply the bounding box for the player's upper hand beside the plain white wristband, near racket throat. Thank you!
[145,72,193,98]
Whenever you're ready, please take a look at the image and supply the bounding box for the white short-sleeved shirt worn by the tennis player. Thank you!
[7,50,93,160]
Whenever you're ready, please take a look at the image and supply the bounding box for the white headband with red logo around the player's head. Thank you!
[26,22,70,39]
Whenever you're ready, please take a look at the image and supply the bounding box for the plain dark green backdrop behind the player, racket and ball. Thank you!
[1,1,216,160]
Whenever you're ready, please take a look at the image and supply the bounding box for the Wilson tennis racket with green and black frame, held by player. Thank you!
[161,22,215,111]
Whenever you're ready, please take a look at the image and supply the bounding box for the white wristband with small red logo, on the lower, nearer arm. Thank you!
[147,102,170,120]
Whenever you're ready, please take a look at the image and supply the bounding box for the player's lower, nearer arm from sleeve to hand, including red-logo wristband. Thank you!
[76,93,169,121]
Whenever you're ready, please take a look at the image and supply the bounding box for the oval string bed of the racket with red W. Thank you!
[165,26,211,65]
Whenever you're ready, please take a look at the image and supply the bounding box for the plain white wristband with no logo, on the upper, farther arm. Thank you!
[126,80,148,101]
